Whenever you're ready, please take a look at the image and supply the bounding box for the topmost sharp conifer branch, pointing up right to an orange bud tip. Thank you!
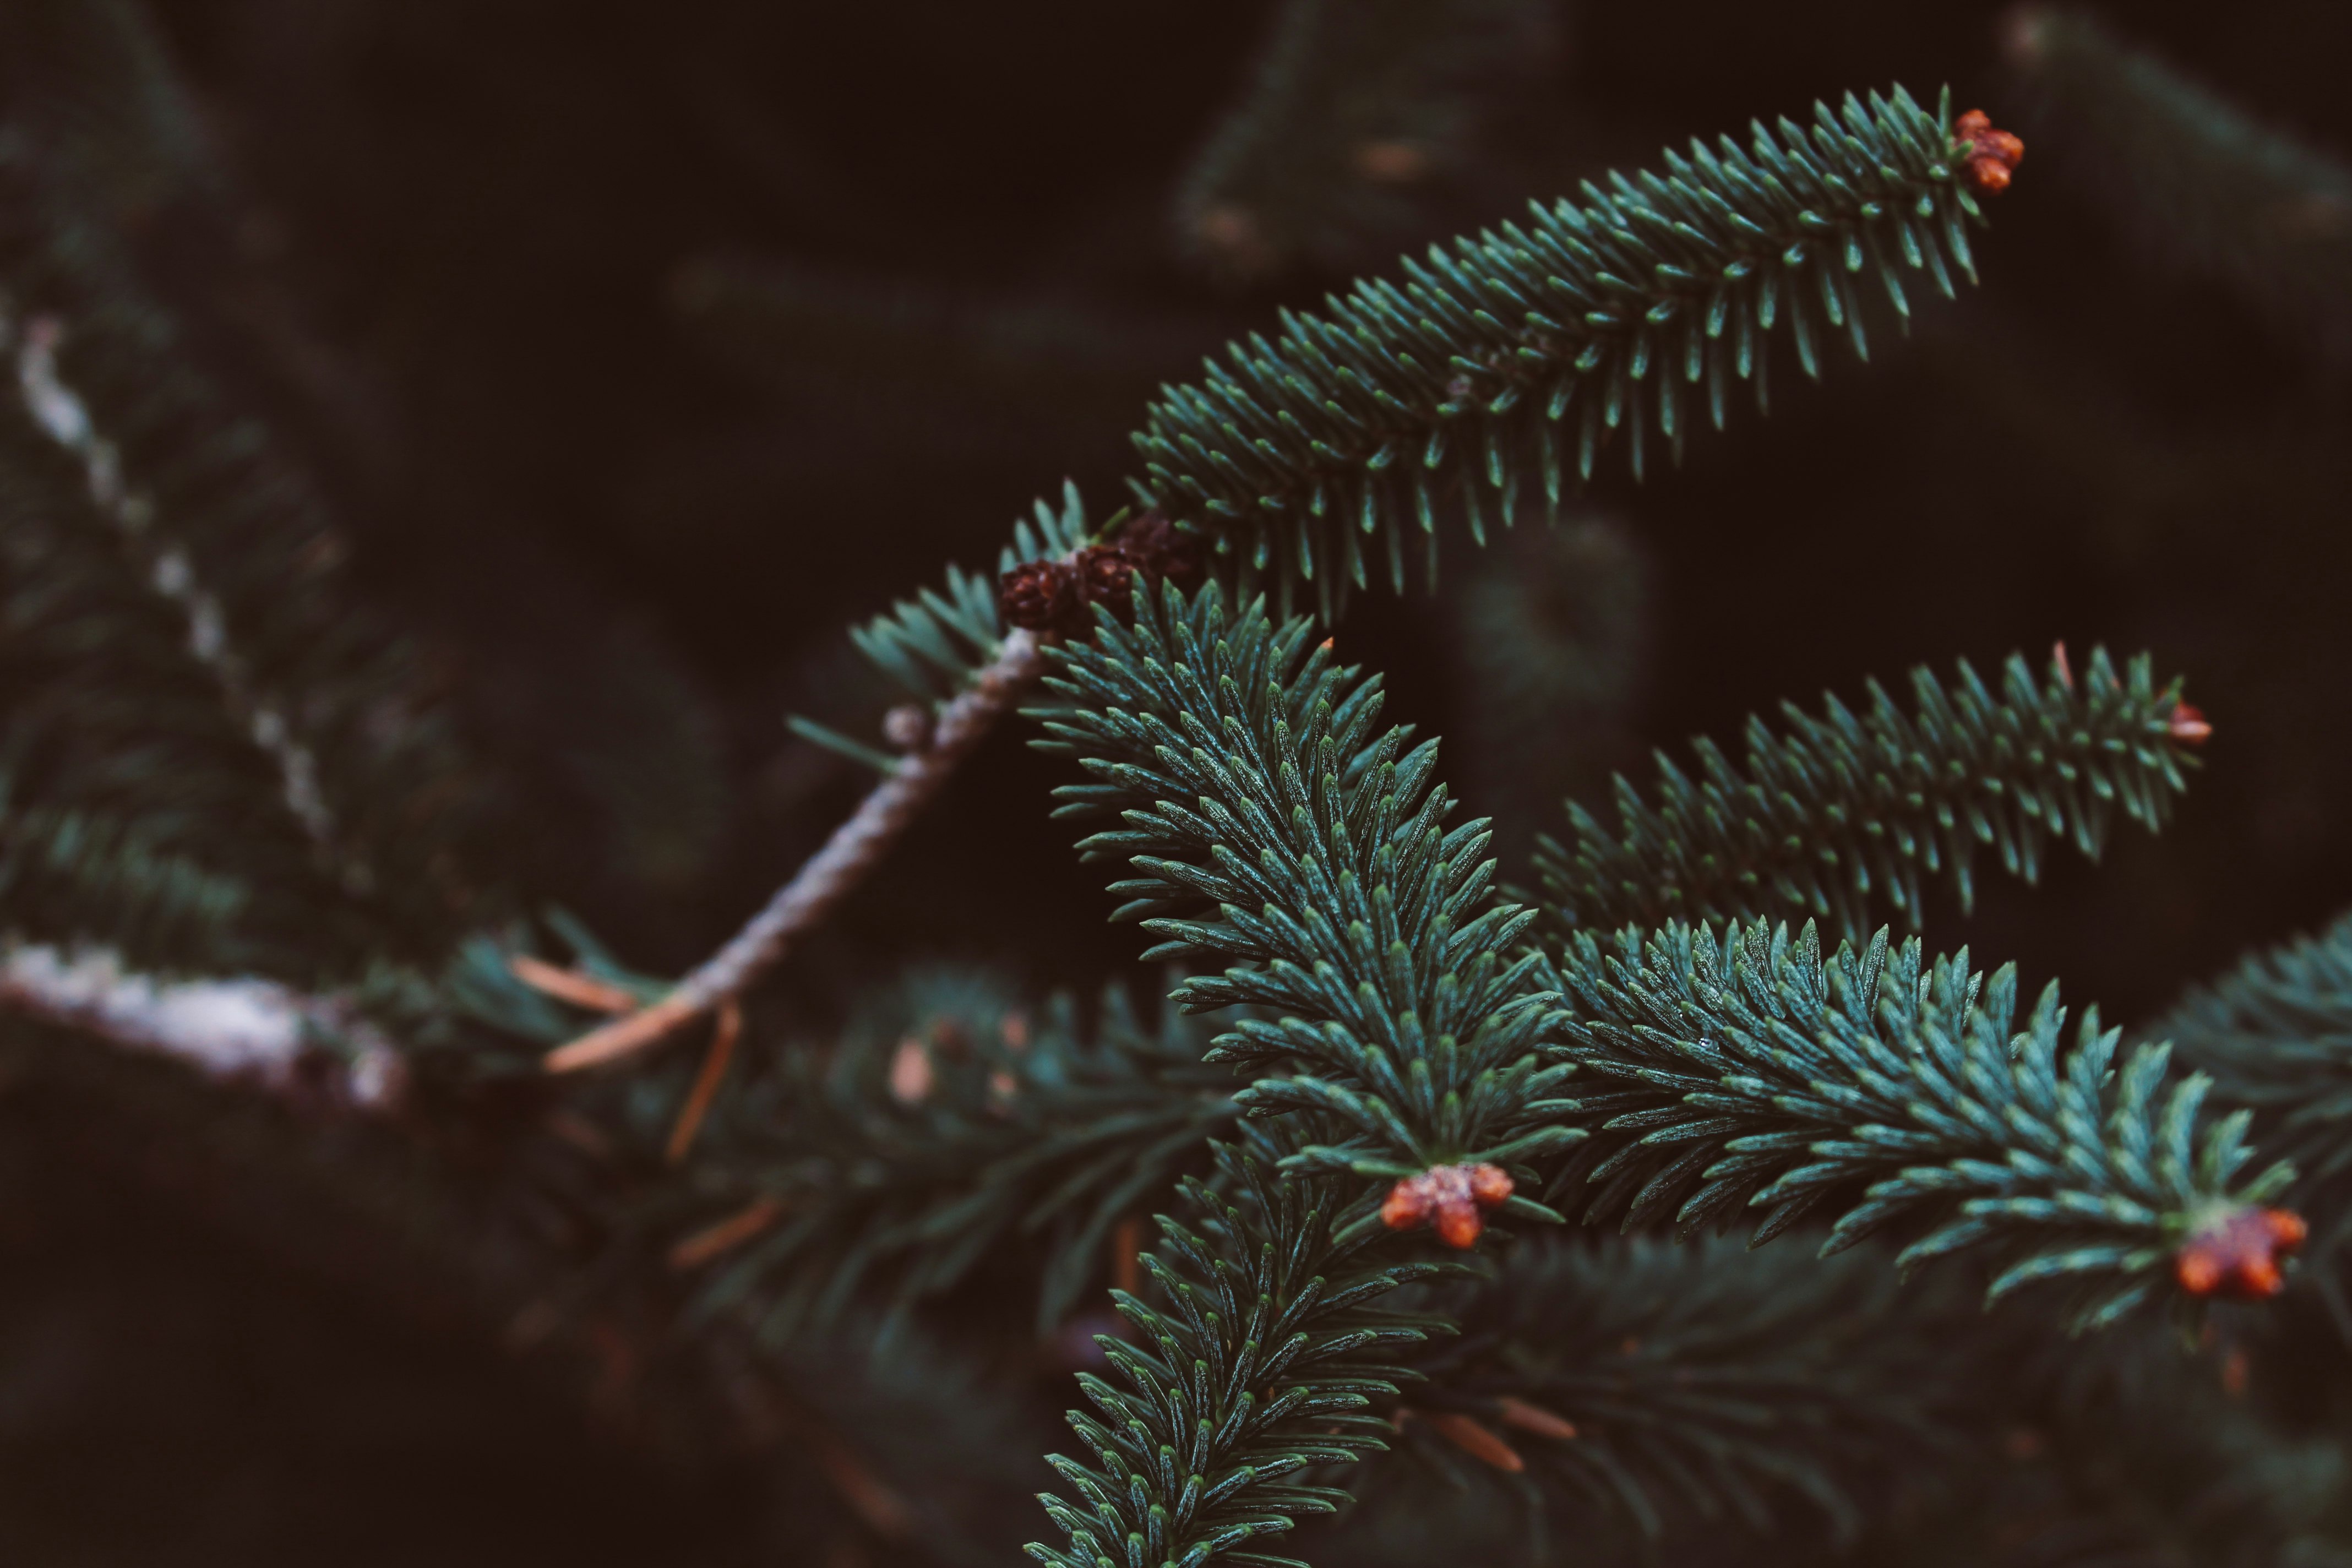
[1136,87,2016,618]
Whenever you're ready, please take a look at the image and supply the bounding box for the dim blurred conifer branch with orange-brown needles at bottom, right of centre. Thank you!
[1352,1234,1985,1544]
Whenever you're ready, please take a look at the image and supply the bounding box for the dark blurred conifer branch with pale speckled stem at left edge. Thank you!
[0,5,489,978]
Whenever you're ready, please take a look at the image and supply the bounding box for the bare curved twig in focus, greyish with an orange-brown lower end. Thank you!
[546,628,1044,1072]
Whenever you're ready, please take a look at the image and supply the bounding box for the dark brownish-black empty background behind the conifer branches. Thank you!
[0,0,2352,1563]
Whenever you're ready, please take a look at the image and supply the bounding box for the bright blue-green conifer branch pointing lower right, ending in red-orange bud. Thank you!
[1559,924,2300,1326]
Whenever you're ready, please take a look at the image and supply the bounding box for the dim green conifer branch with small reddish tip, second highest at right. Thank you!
[1536,646,2211,940]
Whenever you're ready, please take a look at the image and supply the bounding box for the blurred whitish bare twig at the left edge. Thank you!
[0,945,407,1112]
